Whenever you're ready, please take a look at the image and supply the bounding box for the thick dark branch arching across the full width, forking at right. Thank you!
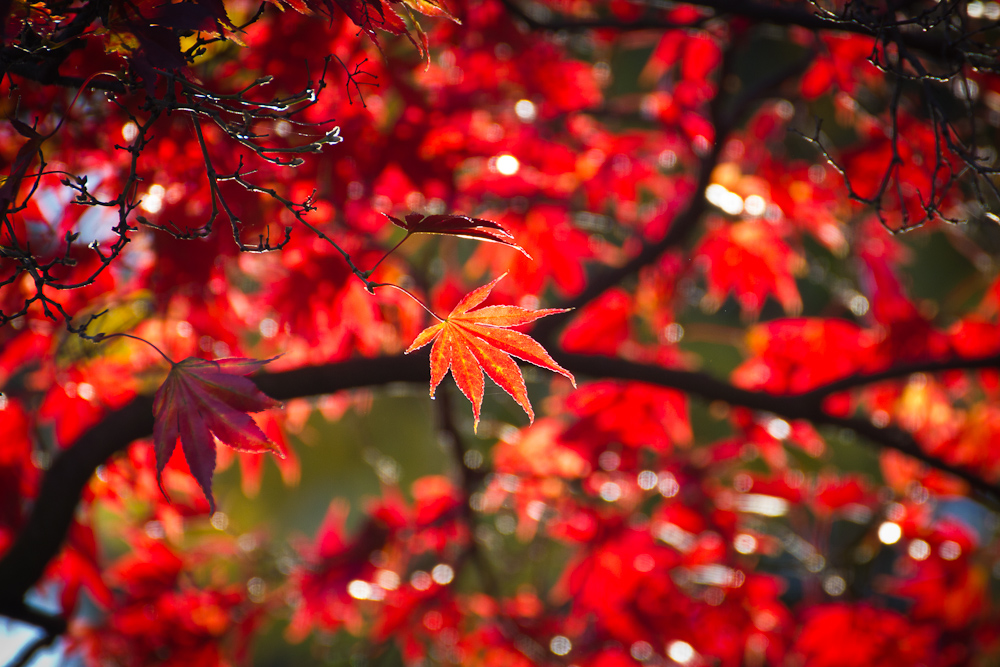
[0,350,1000,630]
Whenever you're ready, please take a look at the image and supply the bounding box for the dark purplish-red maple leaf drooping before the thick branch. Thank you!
[153,357,284,512]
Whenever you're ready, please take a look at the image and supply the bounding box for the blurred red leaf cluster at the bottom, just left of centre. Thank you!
[288,476,469,662]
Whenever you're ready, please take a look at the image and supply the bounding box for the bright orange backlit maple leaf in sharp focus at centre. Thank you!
[406,273,576,427]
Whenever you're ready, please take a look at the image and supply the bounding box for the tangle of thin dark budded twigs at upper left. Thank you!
[0,2,377,334]
